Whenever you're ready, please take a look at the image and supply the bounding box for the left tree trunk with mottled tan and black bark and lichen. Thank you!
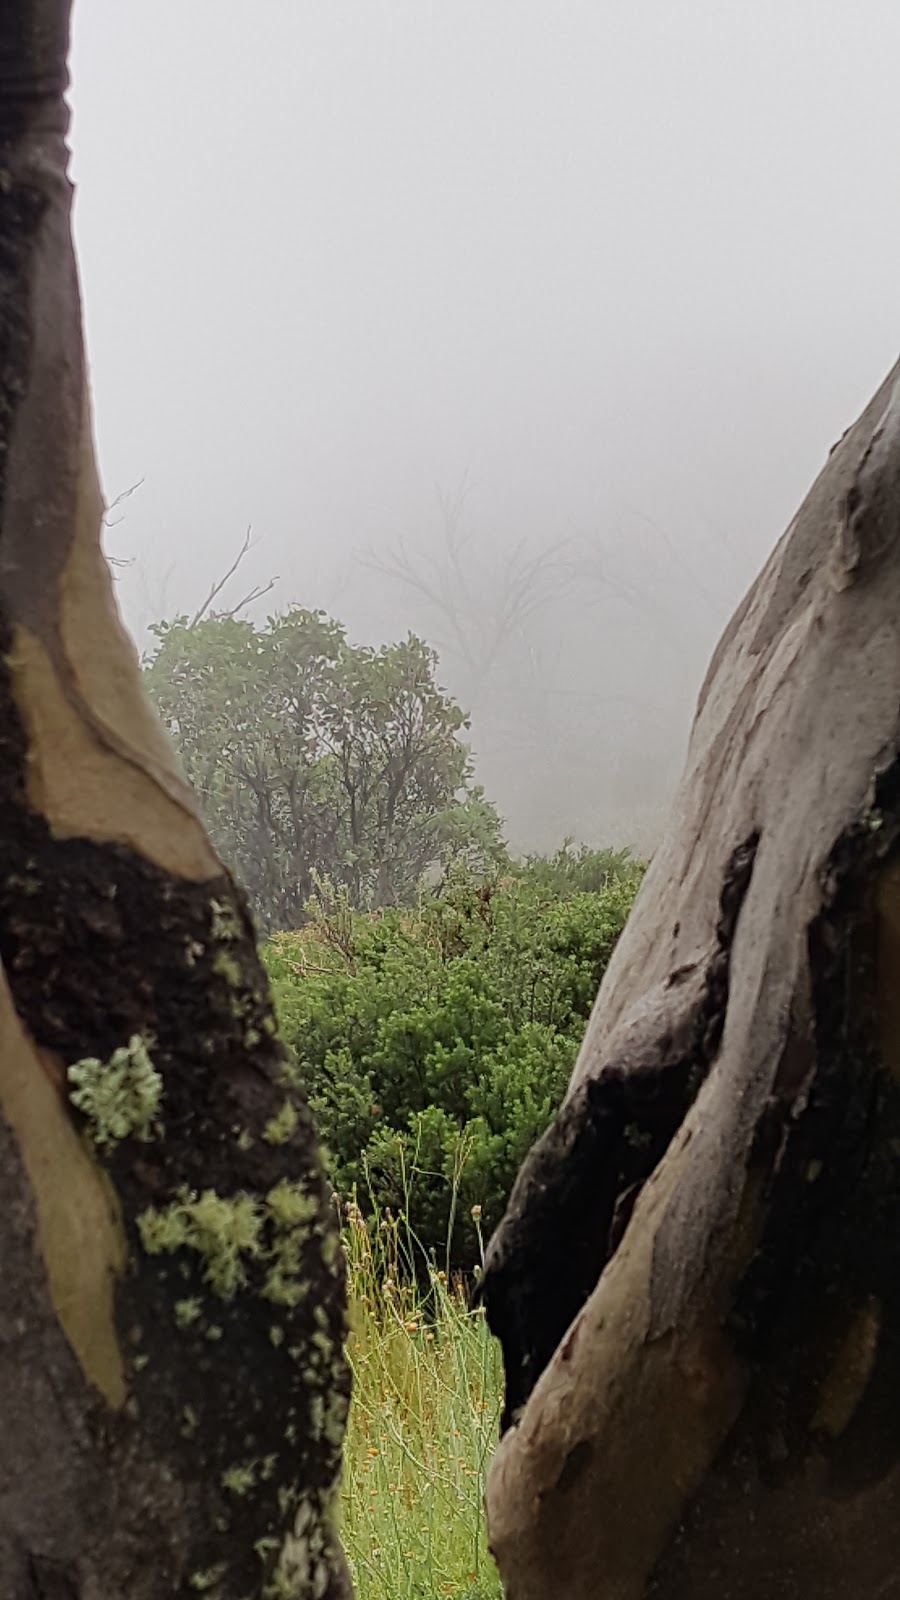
[0,0,349,1600]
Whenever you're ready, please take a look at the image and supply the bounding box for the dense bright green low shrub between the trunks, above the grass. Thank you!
[264,853,642,1267]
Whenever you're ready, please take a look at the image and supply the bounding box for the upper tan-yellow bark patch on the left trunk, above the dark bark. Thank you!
[8,403,221,882]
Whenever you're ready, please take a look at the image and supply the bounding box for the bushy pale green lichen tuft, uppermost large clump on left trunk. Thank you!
[67,1034,163,1149]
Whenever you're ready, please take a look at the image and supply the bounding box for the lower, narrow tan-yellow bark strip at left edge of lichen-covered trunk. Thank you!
[0,978,127,1408]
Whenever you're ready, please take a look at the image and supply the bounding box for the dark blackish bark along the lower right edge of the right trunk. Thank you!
[649,760,900,1600]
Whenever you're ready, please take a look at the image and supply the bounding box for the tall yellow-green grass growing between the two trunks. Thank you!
[343,1202,501,1600]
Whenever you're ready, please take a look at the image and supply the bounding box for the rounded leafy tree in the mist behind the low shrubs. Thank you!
[146,608,501,928]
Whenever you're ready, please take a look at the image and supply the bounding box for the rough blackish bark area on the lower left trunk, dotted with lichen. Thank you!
[0,620,349,1597]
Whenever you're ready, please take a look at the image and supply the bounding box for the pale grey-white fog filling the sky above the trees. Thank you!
[70,0,900,848]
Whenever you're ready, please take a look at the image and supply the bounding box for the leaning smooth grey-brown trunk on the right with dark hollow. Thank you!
[484,363,900,1600]
